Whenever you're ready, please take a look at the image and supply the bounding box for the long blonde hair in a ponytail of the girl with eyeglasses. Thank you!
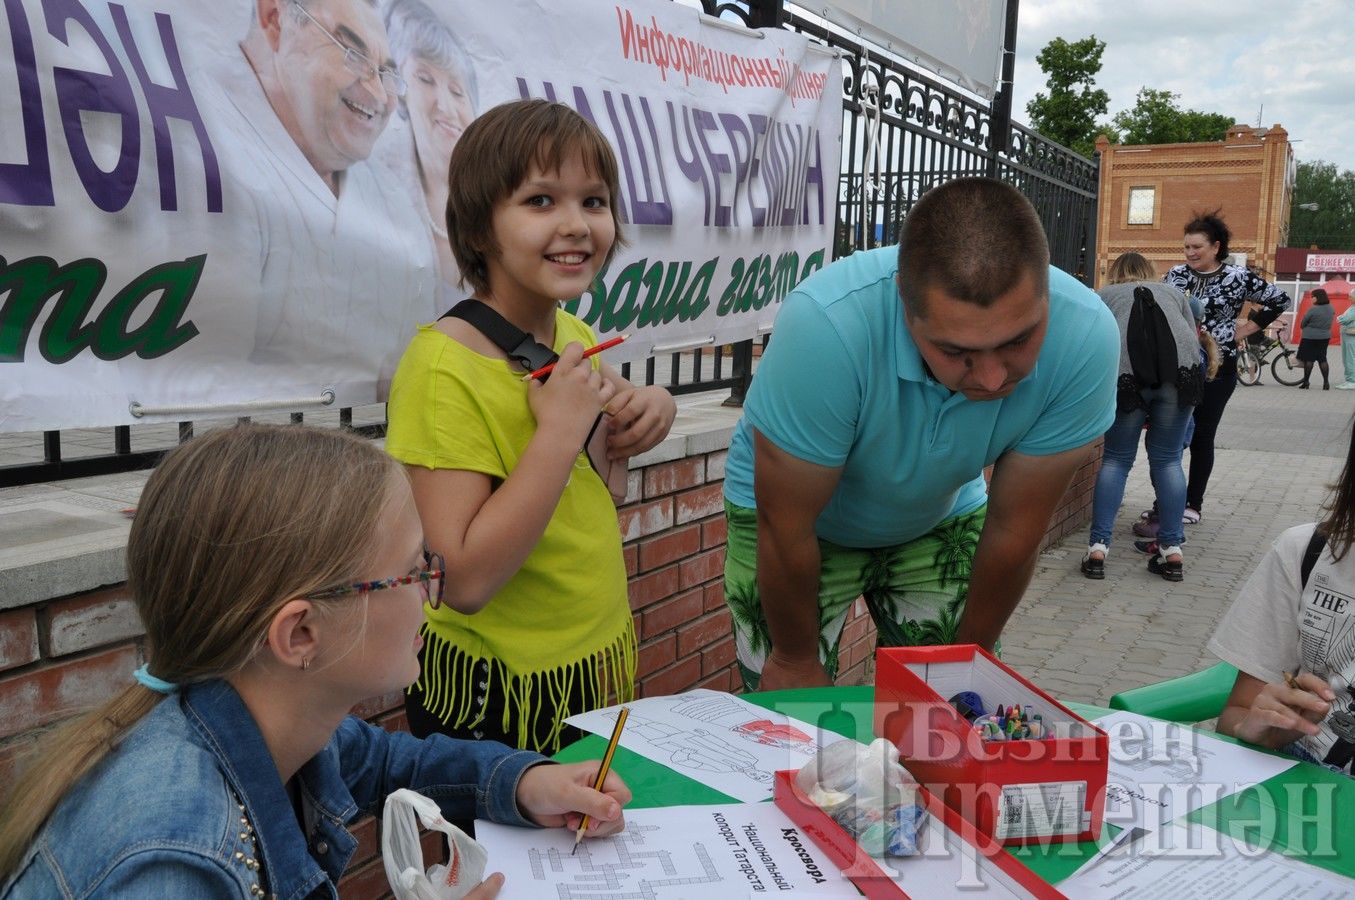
[0,424,405,884]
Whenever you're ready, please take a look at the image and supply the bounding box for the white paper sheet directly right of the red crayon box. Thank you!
[1096,712,1295,830]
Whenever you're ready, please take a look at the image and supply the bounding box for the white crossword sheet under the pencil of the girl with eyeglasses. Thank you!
[476,802,860,900]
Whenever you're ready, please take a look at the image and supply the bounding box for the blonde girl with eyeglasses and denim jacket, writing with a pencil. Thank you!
[0,426,630,900]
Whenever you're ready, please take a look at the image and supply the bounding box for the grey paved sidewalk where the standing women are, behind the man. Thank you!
[1003,348,1355,703]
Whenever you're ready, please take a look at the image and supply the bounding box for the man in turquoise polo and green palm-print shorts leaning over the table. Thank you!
[725,179,1119,690]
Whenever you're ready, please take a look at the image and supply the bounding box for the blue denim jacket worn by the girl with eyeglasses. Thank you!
[0,680,545,900]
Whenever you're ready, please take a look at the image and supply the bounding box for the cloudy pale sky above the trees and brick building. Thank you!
[1012,0,1355,169]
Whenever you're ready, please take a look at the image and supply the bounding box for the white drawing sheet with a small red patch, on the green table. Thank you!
[565,690,846,802]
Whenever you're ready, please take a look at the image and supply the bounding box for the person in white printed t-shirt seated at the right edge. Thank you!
[1209,417,1355,774]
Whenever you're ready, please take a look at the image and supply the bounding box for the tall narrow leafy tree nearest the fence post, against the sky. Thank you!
[1026,34,1110,156]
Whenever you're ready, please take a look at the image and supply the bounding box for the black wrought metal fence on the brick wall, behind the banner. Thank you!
[0,0,1098,487]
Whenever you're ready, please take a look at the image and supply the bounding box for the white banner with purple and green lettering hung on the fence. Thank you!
[0,0,841,431]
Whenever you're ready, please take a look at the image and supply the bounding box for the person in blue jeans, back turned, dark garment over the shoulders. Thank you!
[1081,253,1205,581]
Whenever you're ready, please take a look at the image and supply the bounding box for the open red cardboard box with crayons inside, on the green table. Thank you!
[875,644,1110,844]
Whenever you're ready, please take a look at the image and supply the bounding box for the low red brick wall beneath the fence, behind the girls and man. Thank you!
[0,441,1100,900]
